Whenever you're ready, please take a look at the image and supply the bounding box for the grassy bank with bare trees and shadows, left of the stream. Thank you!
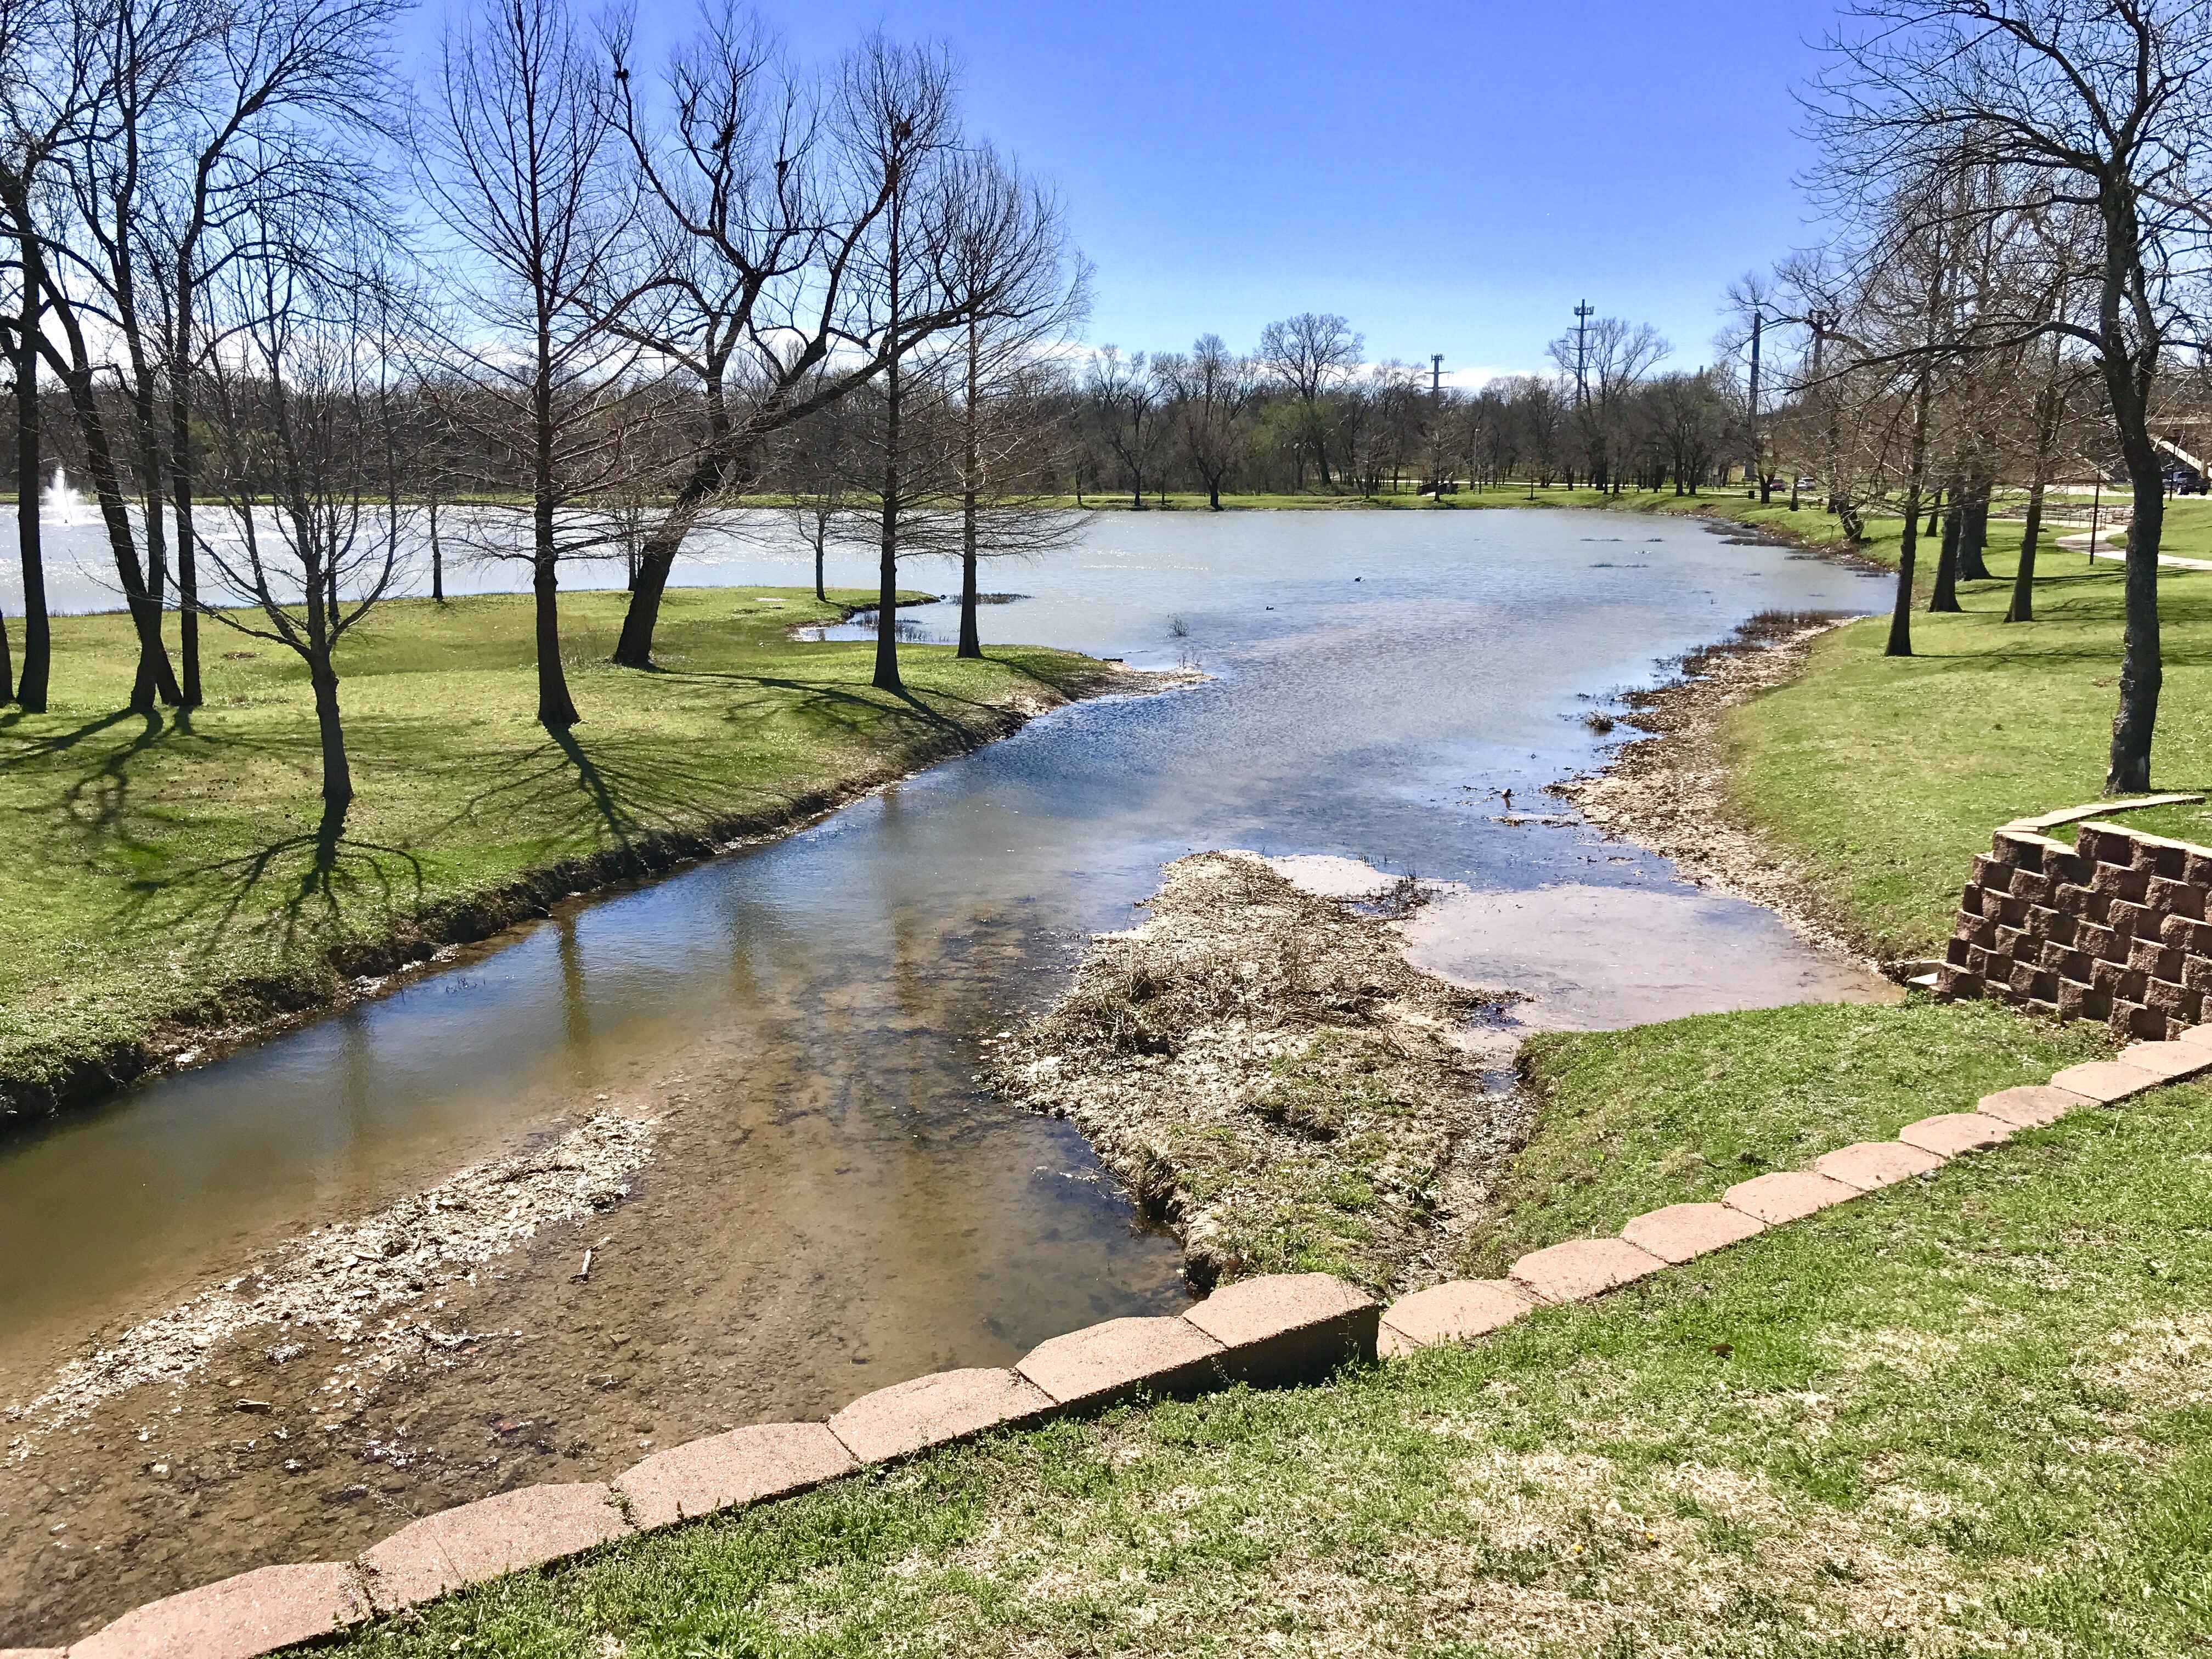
[0,589,1124,1124]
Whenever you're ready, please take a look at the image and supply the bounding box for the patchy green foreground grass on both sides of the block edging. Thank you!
[316,1007,2212,1659]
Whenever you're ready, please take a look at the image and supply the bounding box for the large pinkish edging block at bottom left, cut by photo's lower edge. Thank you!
[71,1562,369,1659]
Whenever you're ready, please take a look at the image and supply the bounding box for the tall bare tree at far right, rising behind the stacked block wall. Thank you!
[1820,0,2212,792]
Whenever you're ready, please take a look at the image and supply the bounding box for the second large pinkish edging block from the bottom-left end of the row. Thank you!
[360,1480,630,1612]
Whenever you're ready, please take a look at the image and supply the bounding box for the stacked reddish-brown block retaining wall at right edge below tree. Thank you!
[1936,814,2212,1042]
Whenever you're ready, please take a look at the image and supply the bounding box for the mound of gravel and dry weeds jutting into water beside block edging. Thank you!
[986,851,1520,1292]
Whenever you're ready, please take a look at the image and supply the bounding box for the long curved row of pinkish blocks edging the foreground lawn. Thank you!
[52,1044,2212,1659]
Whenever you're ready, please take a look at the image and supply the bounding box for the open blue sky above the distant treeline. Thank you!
[425,0,1836,382]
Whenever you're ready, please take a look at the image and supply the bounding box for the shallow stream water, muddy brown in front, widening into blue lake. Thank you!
[0,511,1882,1646]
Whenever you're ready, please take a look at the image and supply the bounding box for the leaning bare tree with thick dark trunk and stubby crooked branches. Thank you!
[608,4,995,668]
